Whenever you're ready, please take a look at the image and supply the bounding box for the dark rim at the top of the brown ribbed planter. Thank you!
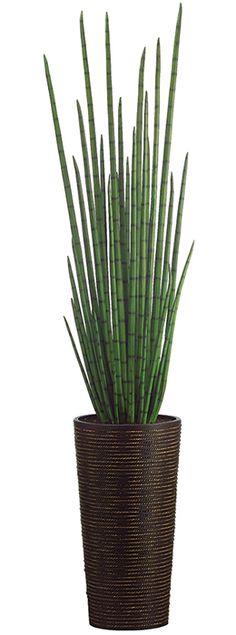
[73,414,181,430]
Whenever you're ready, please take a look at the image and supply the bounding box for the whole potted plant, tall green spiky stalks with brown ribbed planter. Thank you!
[45,5,193,630]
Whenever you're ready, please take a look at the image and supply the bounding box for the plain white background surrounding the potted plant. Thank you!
[0,0,236,635]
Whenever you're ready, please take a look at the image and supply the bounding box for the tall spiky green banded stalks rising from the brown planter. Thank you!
[44,5,194,423]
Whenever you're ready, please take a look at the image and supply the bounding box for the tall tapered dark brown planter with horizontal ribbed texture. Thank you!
[74,415,181,630]
